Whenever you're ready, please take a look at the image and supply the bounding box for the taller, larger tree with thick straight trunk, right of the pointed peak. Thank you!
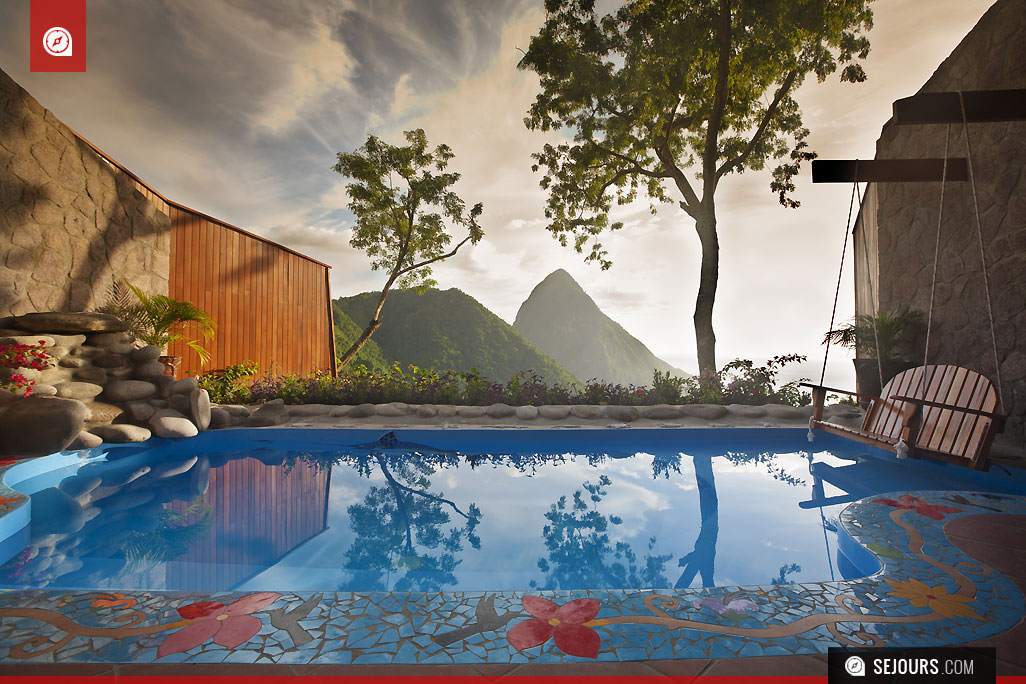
[519,0,872,371]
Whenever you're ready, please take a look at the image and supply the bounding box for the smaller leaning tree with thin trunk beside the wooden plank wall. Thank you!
[334,128,484,368]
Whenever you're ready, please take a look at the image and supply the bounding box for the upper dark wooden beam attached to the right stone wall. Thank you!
[894,89,1026,125]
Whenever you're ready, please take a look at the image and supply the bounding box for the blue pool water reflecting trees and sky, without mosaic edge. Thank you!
[0,429,1026,591]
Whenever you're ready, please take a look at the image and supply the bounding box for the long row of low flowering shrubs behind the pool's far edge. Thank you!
[240,355,812,406]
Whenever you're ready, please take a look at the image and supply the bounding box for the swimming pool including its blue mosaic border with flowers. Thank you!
[0,429,1026,662]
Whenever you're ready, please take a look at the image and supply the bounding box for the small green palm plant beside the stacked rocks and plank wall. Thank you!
[125,281,216,377]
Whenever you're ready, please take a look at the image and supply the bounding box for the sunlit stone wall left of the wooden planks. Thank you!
[0,66,170,319]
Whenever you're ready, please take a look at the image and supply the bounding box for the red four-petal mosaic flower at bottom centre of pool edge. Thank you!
[506,596,602,658]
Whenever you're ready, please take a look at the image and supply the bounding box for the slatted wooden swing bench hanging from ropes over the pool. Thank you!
[803,365,1004,471]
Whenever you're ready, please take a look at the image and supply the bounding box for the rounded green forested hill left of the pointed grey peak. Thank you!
[332,288,580,385]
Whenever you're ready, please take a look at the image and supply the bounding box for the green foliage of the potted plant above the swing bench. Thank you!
[823,306,926,361]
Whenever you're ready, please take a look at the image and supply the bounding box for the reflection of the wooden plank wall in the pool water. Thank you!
[165,458,331,591]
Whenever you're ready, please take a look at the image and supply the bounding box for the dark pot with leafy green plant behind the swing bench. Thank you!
[823,307,925,396]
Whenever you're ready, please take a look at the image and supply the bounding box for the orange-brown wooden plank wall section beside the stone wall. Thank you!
[168,203,334,378]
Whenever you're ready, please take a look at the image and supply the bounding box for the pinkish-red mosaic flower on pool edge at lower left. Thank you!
[157,592,281,658]
